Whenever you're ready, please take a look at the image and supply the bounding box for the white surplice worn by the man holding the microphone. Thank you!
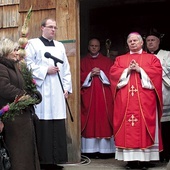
[26,38,72,120]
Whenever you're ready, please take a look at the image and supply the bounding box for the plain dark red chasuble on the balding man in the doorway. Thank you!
[80,54,113,138]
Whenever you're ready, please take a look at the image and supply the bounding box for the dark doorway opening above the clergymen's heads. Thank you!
[80,0,170,56]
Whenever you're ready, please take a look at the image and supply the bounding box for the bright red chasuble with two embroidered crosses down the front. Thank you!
[110,52,162,150]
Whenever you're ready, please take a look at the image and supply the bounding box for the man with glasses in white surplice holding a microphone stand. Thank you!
[26,18,72,170]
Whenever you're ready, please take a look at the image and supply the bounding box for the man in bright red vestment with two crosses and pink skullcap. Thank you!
[110,32,163,169]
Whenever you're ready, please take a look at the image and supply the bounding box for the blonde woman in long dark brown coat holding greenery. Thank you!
[0,38,40,170]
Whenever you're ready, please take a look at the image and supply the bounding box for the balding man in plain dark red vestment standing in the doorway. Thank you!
[80,39,115,158]
